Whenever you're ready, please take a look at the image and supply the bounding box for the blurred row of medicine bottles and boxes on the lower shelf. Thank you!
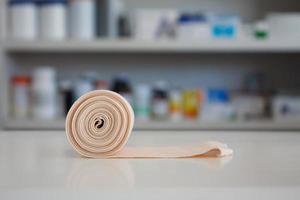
[10,67,300,121]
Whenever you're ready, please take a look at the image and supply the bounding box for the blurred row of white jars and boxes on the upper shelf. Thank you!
[8,0,300,40]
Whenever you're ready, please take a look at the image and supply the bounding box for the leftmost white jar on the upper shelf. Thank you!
[9,0,37,40]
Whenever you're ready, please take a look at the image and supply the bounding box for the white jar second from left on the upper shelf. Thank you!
[39,0,67,40]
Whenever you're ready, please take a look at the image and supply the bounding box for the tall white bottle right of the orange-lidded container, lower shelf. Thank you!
[32,67,58,119]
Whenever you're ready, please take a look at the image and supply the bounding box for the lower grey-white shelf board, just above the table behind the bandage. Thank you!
[4,120,300,131]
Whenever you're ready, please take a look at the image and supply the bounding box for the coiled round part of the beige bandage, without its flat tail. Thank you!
[66,90,134,158]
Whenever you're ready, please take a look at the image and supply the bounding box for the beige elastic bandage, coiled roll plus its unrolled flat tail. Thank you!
[66,90,233,158]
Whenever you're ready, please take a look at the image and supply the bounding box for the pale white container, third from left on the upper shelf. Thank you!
[70,0,96,40]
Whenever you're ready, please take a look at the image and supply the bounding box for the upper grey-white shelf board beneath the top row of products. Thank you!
[4,39,300,53]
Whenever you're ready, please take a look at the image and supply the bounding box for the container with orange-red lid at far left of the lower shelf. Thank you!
[11,76,31,119]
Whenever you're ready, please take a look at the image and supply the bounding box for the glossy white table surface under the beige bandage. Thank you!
[0,131,300,200]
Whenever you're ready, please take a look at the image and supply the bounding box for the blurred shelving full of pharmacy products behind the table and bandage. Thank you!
[0,0,300,130]
